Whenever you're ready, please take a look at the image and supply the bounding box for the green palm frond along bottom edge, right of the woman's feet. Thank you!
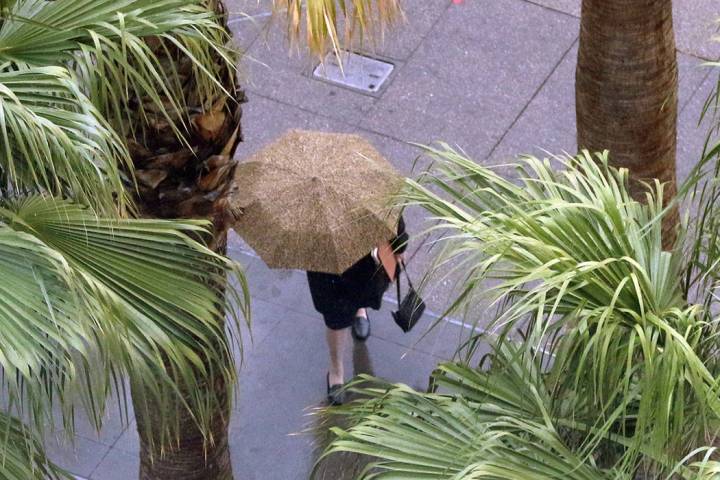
[318,344,620,480]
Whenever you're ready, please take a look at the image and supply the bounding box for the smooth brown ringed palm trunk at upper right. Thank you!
[575,0,678,247]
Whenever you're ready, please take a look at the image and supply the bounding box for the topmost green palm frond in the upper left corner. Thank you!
[0,0,235,140]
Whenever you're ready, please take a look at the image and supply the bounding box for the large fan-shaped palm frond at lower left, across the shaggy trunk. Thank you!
[0,197,248,442]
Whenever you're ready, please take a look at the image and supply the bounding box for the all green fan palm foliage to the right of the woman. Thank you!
[320,147,720,479]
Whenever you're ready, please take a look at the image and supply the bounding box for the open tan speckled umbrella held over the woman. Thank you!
[229,130,402,273]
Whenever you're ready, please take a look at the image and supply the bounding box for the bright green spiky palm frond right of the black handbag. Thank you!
[390,148,720,468]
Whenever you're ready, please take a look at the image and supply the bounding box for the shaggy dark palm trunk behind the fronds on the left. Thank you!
[128,0,245,480]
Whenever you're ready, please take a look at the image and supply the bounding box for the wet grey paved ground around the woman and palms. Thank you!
[47,0,720,480]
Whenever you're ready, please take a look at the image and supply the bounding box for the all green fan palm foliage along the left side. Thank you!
[0,0,246,478]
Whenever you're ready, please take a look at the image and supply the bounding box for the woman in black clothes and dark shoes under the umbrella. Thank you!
[307,217,408,405]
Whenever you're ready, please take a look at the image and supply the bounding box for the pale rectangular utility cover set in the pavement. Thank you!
[313,52,395,93]
